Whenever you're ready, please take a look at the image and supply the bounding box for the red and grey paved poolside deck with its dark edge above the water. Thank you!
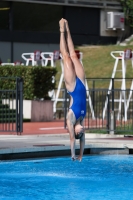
[0,121,133,160]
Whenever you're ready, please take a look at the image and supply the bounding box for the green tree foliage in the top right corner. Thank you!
[120,0,133,27]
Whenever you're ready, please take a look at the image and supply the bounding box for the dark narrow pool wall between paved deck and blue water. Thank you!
[0,147,133,160]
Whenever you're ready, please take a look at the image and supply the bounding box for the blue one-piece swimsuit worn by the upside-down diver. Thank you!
[68,77,86,120]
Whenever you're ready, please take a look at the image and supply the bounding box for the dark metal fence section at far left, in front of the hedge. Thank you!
[0,77,23,134]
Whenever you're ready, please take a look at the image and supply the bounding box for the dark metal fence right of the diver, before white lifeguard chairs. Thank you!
[64,78,133,134]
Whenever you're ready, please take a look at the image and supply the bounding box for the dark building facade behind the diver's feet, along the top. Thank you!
[0,0,122,62]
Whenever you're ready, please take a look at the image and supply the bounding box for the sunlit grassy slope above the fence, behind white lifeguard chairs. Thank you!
[56,45,133,80]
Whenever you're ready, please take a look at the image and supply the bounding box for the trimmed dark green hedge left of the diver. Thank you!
[0,66,57,100]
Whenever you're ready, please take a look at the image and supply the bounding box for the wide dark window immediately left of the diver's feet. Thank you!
[13,2,63,32]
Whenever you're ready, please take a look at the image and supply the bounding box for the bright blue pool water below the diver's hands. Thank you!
[0,155,133,200]
